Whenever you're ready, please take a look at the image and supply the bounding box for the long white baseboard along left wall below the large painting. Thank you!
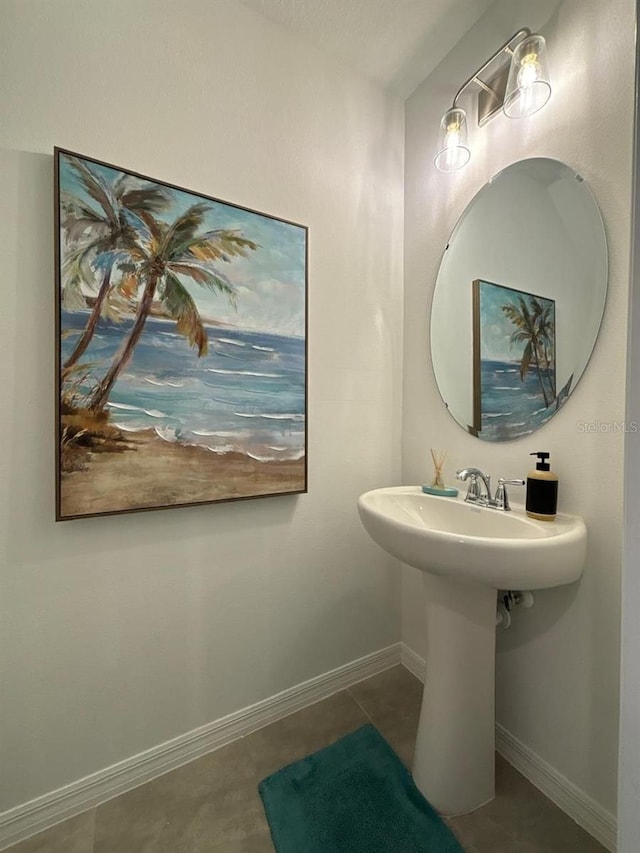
[0,643,401,850]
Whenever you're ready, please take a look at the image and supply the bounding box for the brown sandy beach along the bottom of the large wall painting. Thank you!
[61,430,305,517]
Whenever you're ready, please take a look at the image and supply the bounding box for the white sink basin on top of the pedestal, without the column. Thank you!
[358,486,587,589]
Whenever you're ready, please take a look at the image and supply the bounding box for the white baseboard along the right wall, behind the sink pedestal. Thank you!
[400,643,617,851]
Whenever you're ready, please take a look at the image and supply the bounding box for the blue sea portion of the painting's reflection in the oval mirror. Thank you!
[480,360,557,441]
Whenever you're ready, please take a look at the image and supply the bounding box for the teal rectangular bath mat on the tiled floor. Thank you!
[258,725,464,853]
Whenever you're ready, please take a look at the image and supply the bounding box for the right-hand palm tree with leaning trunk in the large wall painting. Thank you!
[89,204,258,411]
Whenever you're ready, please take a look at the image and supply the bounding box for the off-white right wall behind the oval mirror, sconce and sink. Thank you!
[402,0,635,813]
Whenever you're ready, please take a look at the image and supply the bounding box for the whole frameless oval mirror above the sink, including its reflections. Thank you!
[431,158,607,441]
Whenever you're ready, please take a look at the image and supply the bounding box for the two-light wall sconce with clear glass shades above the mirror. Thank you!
[434,27,551,172]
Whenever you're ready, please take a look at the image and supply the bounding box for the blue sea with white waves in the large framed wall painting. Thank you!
[61,312,306,461]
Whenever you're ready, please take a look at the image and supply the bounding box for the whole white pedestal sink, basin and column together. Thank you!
[358,486,587,816]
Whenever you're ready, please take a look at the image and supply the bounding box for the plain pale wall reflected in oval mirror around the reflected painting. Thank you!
[430,157,607,441]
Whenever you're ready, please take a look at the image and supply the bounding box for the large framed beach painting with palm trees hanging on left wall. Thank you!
[54,148,308,520]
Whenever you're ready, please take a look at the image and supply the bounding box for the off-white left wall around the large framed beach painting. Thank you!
[0,0,403,811]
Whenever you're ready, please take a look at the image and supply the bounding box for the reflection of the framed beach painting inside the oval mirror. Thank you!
[470,279,566,441]
